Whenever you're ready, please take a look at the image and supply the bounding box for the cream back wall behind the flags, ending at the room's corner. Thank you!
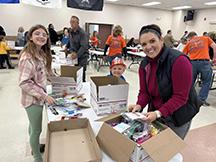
[0,1,172,38]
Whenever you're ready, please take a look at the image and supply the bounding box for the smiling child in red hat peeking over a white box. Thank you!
[108,57,126,81]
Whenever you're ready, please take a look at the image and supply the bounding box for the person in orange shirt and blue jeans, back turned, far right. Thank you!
[183,32,216,106]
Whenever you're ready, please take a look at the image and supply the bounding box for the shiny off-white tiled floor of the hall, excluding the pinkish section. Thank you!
[0,61,216,162]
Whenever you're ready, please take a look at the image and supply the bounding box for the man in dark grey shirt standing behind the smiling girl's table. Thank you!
[67,16,89,82]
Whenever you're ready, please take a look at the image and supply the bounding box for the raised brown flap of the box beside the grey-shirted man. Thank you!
[61,65,81,81]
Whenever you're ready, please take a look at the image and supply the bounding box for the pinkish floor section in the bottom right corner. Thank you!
[182,123,216,162]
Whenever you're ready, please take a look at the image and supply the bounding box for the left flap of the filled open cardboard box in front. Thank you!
[96,123,136,162]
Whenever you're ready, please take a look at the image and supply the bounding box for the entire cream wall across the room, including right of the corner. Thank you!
[0,0,216,39]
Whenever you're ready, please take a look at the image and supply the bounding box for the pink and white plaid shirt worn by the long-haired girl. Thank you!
[19,53,47,108]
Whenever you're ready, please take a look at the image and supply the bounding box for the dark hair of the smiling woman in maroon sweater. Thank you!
[139,24,162,38]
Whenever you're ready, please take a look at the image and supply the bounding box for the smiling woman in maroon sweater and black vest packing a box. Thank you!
[128,24,201,139]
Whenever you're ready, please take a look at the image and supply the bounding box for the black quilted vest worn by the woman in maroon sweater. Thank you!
[140,47,201,126]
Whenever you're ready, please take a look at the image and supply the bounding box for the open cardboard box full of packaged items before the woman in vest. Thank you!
[97,115,185,162]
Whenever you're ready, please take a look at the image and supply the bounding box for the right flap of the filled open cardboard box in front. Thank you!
[141,128,185,162]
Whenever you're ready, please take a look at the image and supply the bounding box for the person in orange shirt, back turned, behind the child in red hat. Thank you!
[104,25,127,65]
